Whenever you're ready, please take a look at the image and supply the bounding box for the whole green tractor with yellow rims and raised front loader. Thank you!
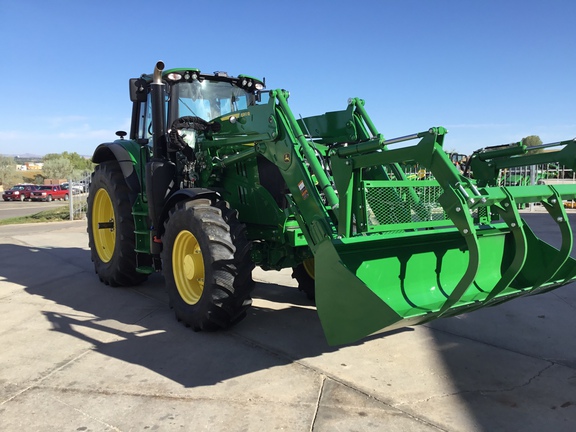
[88,62,576,345]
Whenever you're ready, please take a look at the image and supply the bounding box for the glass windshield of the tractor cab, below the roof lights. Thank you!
[170,79,254,122]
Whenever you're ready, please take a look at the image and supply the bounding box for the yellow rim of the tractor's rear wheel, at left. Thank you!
[92,189,116,263]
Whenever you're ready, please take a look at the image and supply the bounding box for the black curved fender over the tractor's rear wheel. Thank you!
[92,140,141,196]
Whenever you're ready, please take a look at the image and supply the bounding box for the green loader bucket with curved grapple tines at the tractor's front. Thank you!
[315,186,576,345]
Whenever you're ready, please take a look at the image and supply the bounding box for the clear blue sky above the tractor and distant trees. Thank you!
[0,0,576,155]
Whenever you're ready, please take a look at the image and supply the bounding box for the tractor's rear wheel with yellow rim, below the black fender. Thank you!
[87,161,147,286]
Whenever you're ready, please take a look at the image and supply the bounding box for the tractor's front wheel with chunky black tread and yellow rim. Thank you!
[162,198,254,331]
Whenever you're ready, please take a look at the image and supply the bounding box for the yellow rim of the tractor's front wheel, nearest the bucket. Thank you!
[172,231,205,305]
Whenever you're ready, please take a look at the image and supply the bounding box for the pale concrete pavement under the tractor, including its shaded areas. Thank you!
[0,219,576,432]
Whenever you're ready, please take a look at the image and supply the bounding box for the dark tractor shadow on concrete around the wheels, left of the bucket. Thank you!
[0,244,396,388]
